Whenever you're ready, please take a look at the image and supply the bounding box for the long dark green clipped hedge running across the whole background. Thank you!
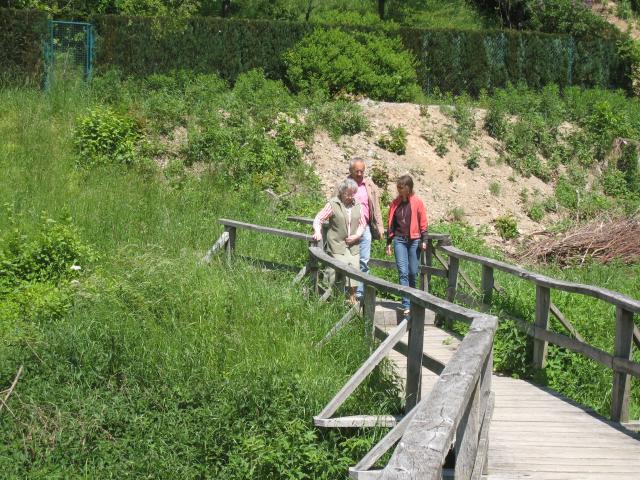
[0,10,630,94]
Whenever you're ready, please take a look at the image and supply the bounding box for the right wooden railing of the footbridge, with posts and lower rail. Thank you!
[438,245,640,422]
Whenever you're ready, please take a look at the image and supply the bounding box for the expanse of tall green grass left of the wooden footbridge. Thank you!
[0,86,400,479]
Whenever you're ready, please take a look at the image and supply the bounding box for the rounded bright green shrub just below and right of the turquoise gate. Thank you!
[74,107,140,167]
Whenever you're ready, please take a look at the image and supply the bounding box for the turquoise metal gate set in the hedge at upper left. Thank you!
[44,20,95,88]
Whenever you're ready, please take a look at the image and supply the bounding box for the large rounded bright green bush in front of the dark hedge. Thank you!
[283,29,420,101]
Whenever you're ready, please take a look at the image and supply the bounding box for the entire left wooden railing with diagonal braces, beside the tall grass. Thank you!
[205,219,497,479]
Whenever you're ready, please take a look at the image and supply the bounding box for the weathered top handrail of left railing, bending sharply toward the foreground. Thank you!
[309,247,498,480]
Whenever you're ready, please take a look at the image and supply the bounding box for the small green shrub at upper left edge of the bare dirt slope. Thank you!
[309,99,369,140]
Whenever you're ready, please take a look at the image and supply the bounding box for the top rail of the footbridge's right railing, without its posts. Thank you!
[439,246,640,313]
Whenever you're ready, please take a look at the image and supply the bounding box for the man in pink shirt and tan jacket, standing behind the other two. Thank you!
[348,157,384,299]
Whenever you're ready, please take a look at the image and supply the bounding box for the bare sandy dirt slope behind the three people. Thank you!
[305,100,554,242]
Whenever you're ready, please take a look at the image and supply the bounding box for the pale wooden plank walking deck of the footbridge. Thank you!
[376,302,640,480]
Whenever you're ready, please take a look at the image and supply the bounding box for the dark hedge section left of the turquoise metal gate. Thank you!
[0,8,47,82]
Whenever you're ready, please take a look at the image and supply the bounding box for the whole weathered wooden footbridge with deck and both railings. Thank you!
[204,217,640,480]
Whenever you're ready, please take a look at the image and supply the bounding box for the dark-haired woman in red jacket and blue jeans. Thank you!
[387,175,427,317]
